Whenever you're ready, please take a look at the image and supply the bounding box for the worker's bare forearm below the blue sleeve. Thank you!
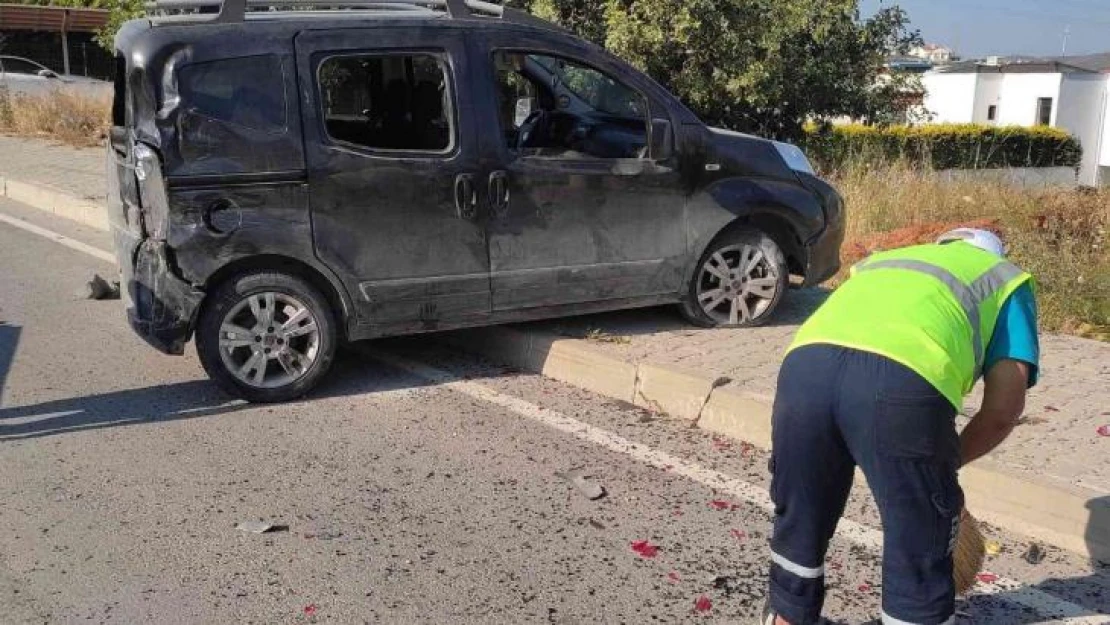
[960,360,1029,464]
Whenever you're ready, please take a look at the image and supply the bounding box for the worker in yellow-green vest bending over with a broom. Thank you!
[761,229,1039,625]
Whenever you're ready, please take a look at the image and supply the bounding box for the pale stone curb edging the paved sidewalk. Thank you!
[0,177,1110,561]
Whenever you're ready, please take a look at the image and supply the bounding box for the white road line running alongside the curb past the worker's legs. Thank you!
[362,347,1110,625]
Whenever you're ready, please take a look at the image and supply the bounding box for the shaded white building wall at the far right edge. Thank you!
[1056,73,1107,187]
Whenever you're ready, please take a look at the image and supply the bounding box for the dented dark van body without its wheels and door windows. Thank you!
[108,9,844,353]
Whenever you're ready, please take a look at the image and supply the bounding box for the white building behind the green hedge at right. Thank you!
[922,53,1110,187]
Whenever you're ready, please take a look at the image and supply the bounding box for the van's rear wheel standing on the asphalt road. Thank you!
[196,271,339,403]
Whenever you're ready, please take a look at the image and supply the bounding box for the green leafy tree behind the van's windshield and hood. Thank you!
[518,0,921,139]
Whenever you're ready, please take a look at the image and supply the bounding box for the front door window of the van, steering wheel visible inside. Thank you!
[493,50,648,159]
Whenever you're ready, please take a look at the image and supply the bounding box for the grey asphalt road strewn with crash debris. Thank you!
[0,200,1110,625]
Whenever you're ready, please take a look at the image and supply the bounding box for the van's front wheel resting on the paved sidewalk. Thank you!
[682,229,790,327]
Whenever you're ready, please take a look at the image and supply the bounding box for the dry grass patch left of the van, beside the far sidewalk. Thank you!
[0,89,112,148]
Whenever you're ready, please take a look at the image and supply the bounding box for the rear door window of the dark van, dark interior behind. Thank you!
[319,54,453,152]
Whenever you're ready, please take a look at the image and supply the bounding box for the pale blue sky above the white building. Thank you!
[860,0,1110,58]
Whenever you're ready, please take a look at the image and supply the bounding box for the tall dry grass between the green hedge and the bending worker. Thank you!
[830,160,1110,340]
